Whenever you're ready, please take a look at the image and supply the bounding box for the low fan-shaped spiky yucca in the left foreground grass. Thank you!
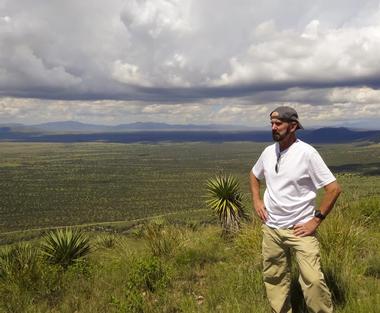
[41,228,90,269]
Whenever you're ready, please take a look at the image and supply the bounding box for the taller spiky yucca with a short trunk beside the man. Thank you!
[206,175,247,235]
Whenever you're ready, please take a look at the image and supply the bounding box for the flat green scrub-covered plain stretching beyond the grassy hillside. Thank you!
[0,142,380,233]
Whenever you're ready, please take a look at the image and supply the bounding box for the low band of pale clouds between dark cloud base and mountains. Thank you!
[0,89,380,128]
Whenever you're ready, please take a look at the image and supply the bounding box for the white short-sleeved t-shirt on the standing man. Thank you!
[252,139,336,228]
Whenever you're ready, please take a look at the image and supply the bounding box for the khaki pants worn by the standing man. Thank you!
[262,225,333,313]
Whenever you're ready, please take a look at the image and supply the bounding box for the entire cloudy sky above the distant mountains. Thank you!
[0,0,380,129]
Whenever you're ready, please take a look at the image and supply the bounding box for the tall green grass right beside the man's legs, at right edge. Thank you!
[319,198,380,312]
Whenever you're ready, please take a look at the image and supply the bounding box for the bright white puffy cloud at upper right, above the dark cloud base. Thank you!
[215,16,380,85]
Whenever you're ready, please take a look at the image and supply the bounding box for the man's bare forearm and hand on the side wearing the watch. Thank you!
[294,181,342,237]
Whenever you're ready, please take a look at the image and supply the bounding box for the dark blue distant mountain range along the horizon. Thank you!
[0,121,380,143]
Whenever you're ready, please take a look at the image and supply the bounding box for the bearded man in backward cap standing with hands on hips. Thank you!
[250,106,341,313]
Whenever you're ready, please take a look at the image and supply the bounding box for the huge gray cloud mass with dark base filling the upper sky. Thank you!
[0,0,380,101]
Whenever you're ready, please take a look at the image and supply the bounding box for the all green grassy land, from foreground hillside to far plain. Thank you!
[0,143,380,313]
